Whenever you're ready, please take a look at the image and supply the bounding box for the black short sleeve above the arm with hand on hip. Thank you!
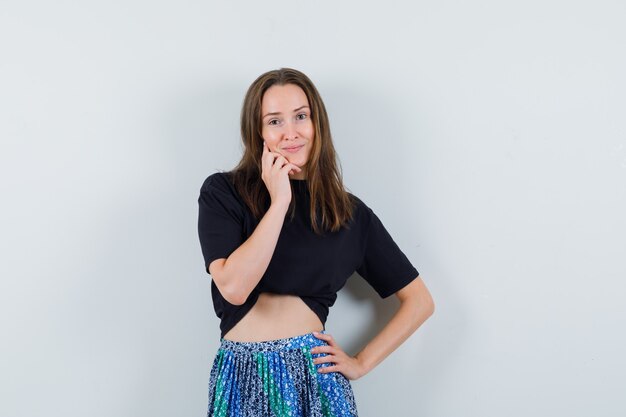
[356,206,419,298]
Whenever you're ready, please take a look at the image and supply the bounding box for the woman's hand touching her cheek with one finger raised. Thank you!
[261,141,302,205]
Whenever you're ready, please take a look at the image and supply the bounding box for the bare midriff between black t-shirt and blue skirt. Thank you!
[224,292,324,342]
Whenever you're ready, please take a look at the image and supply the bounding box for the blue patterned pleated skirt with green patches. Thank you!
[207,330,358,417]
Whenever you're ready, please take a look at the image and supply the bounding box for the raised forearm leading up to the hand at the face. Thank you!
[220,203,289,304]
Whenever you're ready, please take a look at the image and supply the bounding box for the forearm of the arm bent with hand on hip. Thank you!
[355,298,434,373]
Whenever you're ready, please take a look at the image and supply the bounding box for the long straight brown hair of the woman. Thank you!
[228,68,356,235]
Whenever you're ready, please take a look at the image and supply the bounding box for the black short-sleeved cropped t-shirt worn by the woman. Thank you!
[198,172,419,337]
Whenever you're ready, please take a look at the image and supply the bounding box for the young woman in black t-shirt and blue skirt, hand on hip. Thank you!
[198,68,434,417]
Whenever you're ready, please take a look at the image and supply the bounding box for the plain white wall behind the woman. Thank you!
[0,0,626,417]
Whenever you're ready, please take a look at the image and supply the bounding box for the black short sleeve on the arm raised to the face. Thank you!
[198,173,245,273]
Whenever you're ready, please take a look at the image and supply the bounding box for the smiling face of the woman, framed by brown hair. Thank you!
[261,84,314,179]
